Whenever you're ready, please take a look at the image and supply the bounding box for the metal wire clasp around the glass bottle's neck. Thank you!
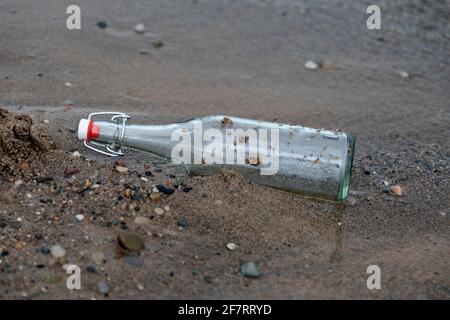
[84,112,131,157]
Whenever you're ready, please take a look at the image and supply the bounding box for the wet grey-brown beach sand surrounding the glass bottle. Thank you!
[0,0,450,299]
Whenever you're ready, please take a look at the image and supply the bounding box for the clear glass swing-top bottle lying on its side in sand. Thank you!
[78,112,355,200]
